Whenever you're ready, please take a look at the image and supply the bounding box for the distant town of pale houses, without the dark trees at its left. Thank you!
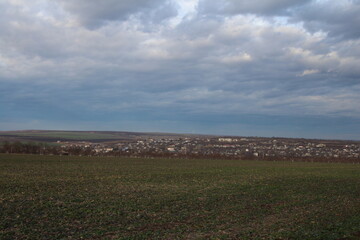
[58,137,360,161]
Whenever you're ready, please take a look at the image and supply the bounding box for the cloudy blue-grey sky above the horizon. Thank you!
[0,0,360,140]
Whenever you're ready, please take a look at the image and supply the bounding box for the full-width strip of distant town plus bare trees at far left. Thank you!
[0,131,360,163]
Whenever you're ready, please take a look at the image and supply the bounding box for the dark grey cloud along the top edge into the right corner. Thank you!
[198,0,360,39]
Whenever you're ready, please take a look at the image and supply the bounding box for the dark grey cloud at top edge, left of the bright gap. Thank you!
[58,0,177,28]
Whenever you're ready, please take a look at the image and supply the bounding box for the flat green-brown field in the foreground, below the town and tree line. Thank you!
[0,155,360,240]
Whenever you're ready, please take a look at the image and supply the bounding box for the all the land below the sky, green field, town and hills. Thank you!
[0,131,360,240]
